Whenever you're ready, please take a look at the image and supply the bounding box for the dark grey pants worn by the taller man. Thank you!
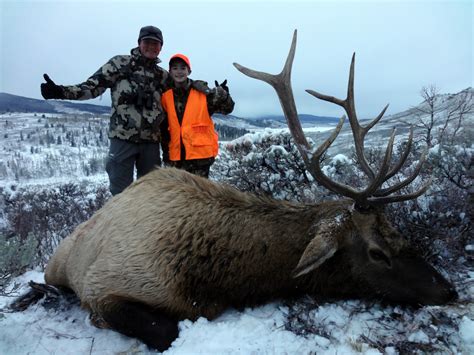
[105,138,161,195]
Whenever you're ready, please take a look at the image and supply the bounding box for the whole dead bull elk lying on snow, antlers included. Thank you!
[45,32,456,350]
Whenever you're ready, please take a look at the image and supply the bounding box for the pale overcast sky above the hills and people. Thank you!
[0,0,473,118]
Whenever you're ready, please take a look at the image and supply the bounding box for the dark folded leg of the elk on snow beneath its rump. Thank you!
[98,296,179,351]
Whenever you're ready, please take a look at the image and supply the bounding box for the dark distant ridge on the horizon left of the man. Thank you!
[0,92,110,115]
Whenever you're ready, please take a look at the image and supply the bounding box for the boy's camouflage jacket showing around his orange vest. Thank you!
[161,79,235,165]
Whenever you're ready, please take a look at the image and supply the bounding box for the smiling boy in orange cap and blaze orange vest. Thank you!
[161,54,234,178]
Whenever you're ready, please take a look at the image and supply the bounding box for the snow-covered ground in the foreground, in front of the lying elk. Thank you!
[0,271,474,355]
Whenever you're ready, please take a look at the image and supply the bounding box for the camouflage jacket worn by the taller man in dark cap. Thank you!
[63,48,168,143]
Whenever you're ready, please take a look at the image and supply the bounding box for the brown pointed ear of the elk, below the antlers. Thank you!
[293,228,338,278]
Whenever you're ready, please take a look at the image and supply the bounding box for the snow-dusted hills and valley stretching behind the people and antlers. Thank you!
[0,88,474,185]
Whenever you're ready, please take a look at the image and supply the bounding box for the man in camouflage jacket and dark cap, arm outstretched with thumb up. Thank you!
[41,26,168,195]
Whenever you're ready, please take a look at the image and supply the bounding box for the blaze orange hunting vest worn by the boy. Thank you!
[161,88,218,161]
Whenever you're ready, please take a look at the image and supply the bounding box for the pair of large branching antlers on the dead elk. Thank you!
[234,30,429,207]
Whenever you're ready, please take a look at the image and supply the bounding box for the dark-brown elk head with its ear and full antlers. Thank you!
[234,30,456,305]
